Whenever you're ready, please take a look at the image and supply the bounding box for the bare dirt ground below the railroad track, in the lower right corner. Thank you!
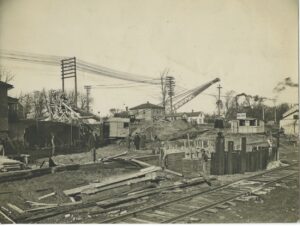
[193,175,299,223]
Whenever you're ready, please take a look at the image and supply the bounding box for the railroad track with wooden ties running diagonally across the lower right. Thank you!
[100,163,298,223]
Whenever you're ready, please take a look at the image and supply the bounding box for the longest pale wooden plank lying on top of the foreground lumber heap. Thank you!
[64,167,161,195]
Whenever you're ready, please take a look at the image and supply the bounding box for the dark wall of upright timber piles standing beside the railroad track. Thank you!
[210,134,278,175]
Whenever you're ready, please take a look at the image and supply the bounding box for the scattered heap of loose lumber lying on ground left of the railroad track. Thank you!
[3,153,216,223]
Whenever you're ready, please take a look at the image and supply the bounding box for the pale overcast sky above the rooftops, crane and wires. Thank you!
[0,0,298,115]
